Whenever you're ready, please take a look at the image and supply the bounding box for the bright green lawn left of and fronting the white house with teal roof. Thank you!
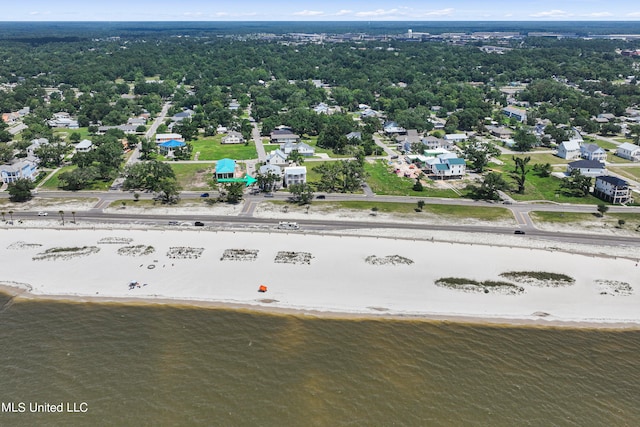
[364,161,460,198]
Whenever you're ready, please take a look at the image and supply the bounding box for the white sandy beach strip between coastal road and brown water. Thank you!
[0,229,640,327]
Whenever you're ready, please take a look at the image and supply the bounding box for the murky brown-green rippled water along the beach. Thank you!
[0,296,640,426]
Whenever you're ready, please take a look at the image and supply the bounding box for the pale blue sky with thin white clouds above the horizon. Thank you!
[5,0,640,21]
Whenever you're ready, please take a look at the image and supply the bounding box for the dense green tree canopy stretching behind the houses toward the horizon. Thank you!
[0,30,640,141]
